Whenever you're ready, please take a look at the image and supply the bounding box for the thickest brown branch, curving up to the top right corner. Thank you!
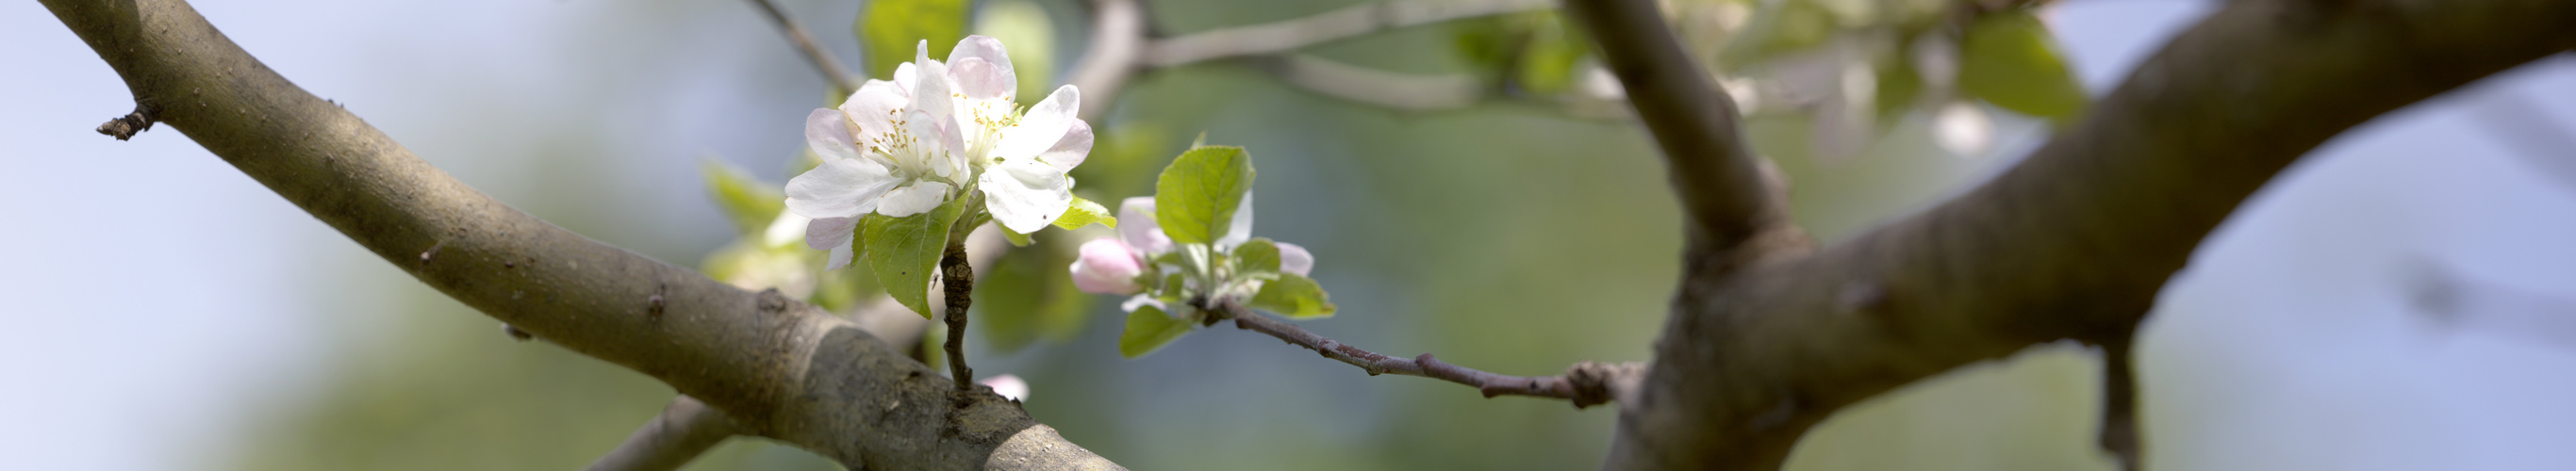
[1579,0,2576,468]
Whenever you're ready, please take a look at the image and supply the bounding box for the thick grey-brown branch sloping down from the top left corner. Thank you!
[43,0,1115,468]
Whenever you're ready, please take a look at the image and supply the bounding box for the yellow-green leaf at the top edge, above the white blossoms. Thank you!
[858,0,966,80]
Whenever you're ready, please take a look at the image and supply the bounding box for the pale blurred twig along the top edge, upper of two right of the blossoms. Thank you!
[1144,0,1553,67]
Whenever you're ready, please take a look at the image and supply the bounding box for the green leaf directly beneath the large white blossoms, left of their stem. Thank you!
[860,198,966,319]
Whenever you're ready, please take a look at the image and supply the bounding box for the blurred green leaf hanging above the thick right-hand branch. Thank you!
[1957,10,2084,119]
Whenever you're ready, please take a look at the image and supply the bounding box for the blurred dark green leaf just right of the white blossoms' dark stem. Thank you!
[974,240,1092,352]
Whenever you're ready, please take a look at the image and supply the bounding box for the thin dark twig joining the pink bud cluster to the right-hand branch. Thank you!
[1218,301,1643,409]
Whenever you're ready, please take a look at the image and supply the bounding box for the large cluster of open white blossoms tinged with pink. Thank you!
[785,36,1092,270]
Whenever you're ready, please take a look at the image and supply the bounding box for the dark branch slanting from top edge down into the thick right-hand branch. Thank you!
[1566,0,1808,275]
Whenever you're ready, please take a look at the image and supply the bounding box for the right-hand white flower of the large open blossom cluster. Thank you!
[952,36,1092,235]
